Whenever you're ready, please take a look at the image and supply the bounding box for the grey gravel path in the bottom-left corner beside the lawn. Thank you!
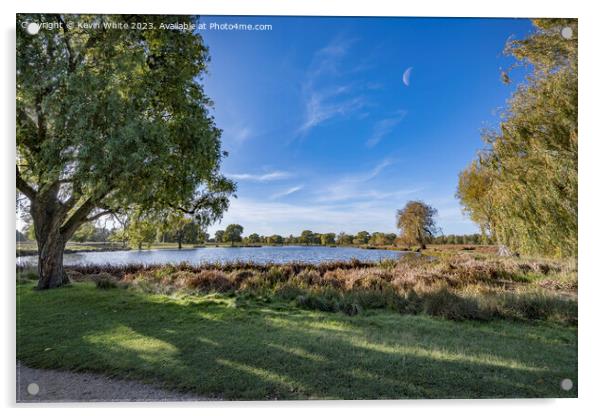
[17,363,211,403]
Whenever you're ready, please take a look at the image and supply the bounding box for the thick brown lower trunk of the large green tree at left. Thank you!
[38,230,69,289]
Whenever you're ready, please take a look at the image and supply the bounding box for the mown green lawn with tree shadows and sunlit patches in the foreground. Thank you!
[17,282,577,400]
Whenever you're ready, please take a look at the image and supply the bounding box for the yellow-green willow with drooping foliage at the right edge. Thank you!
[458,19,578,257]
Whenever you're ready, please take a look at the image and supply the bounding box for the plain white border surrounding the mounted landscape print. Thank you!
[0,0,602,416]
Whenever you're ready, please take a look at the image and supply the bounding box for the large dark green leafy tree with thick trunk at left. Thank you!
[16,15,234,289]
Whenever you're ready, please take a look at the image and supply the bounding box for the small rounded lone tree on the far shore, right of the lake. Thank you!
[397,201,438,249]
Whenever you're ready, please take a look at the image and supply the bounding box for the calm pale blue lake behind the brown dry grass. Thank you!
[17,246,406,266]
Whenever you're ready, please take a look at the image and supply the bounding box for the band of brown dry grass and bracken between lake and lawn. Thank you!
[17,252,577,324]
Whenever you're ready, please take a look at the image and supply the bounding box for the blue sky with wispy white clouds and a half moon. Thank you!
[200,17,532,235]
